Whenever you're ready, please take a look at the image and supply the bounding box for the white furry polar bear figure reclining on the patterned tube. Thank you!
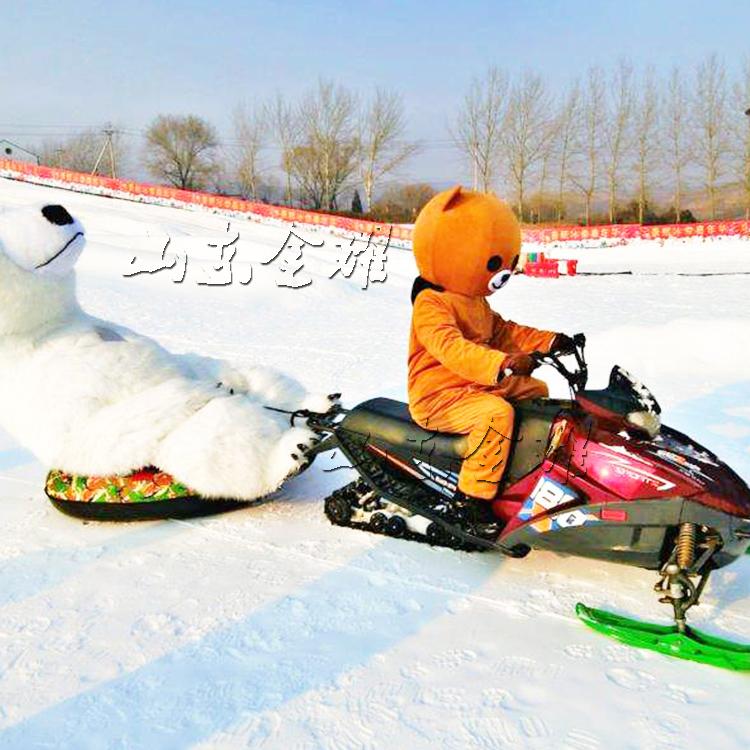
[0,205,335,500]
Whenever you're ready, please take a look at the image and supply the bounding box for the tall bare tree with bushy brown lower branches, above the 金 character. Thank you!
[287,80,359,209]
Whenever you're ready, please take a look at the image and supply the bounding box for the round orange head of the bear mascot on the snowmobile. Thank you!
[413,186,521,297]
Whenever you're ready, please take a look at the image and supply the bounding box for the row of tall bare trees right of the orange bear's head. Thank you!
[451,55,750,224]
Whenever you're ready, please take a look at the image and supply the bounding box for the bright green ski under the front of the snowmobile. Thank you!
[576,602,750,672]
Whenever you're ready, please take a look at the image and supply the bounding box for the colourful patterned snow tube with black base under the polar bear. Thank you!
[45,467,248,521]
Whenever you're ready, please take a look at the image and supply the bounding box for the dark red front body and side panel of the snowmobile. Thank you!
[494,391,750,569]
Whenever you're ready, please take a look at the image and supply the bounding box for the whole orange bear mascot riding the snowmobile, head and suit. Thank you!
[409,187,567,500]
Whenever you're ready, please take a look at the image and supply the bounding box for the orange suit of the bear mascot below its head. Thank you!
[409,289,555,500]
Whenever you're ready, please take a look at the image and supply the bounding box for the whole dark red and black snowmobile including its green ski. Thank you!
[302,334,750,670]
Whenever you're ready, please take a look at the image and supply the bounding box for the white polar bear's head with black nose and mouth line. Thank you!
[0,205,85,336]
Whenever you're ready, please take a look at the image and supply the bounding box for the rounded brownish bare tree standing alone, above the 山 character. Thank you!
[145,115,219,190]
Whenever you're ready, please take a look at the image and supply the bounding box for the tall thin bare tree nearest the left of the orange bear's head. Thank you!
[357,89,418,211]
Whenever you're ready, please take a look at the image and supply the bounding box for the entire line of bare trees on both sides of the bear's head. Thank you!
[35,55,750,224]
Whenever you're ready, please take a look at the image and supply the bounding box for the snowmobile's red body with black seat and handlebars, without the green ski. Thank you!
[311,345,750,569]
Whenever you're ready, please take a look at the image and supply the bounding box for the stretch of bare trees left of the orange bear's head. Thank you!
[35,81,419,220]
